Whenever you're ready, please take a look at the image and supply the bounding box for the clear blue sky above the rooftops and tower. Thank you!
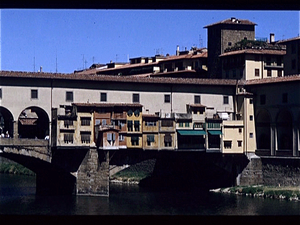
[1,9,300,73]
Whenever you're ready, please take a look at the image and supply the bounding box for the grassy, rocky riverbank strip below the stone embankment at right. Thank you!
[210,185,300,201]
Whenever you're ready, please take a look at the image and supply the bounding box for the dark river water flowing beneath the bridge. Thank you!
[0,174,300,215]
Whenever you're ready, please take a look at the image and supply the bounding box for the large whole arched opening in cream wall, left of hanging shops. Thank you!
[18,106,50,139]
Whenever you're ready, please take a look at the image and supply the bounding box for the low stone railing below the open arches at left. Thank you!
[0,138,49,147]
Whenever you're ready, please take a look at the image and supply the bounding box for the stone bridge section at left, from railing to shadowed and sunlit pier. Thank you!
[0,138,109,196]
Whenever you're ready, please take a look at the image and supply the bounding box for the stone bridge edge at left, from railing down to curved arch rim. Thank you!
[0,138,52,162]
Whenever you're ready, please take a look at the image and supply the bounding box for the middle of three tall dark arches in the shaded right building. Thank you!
[276,109,293,150]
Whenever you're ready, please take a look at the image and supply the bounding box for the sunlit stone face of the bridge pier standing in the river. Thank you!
[76,148,109,196]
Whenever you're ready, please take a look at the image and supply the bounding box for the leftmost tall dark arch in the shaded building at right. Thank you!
[255,109,271,150]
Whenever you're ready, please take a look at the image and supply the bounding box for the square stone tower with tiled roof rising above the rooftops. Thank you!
[204,17,256,78]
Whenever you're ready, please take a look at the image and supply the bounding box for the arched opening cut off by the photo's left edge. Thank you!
[0,106,14,137]
